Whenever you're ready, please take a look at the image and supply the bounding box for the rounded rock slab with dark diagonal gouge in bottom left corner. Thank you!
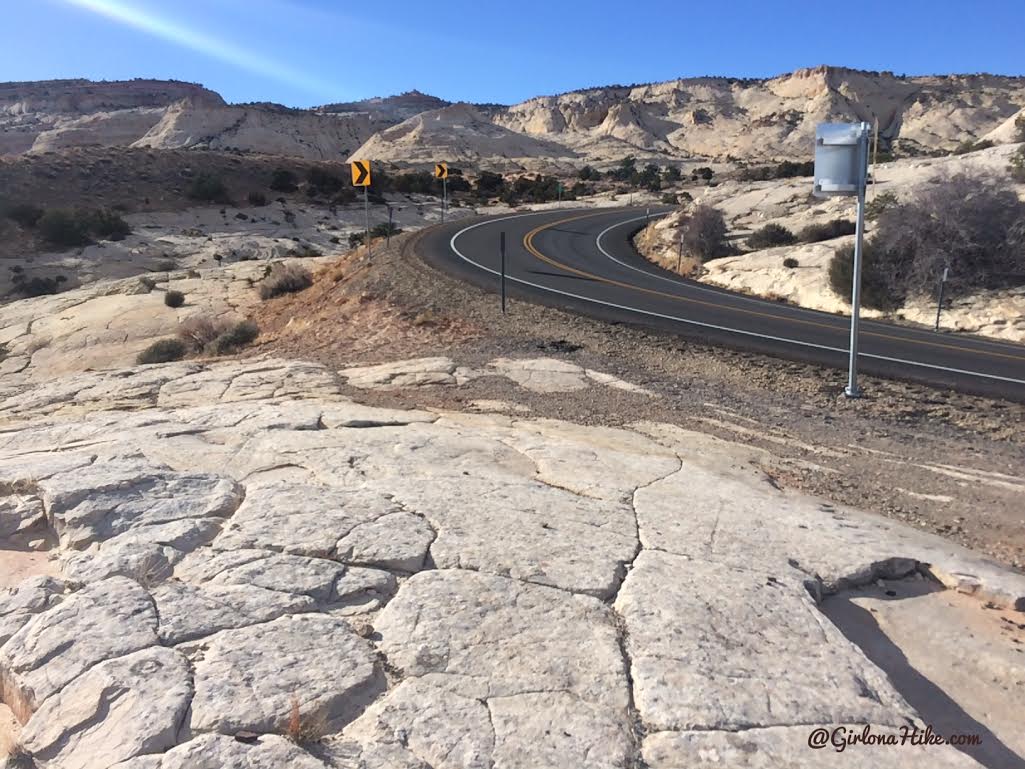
[22,646,193,769]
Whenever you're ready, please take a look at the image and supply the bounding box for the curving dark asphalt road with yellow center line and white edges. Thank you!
[420,208,1025,401]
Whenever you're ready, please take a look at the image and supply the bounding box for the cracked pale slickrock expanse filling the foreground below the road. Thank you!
[0,358,1025,769]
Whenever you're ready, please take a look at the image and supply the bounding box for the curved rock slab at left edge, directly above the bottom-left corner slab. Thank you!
[0,577,158,723]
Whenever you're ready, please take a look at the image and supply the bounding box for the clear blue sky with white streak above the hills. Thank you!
[0,0,1025,107]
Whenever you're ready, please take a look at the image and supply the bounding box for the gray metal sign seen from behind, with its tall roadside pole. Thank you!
[812,123,871,398]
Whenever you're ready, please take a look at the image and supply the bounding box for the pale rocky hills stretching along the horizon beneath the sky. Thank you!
[6,67,1025,166]
